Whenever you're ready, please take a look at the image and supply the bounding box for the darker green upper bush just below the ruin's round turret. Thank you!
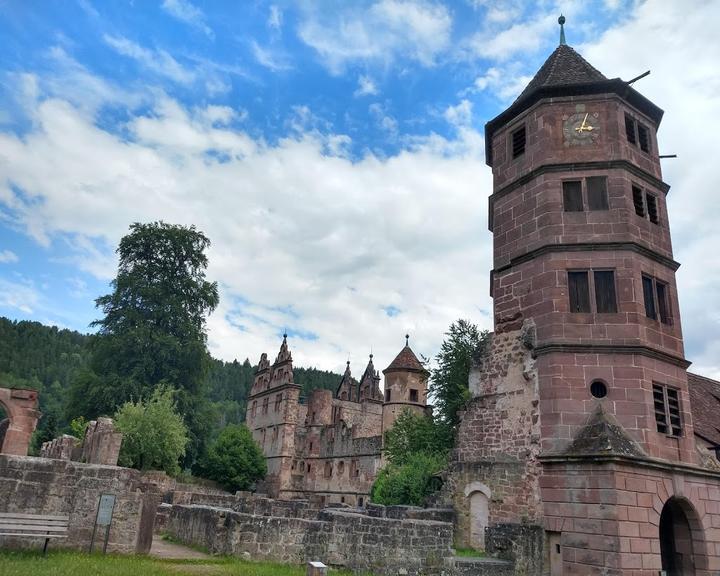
[383,409,453,466]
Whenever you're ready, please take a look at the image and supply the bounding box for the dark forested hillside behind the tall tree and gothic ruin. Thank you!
[0,317,341,430]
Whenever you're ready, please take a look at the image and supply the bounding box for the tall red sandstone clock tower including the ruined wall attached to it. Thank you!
[449,18,720,576]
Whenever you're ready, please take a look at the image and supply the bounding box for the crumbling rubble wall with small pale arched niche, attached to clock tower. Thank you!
[439,322,542,549]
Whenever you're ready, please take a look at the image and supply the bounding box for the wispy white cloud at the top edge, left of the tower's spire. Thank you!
[298,0,452,73]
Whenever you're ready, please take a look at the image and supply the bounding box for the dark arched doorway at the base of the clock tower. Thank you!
[660,497,705,576]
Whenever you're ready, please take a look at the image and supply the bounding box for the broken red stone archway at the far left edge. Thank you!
[0,388,40,456]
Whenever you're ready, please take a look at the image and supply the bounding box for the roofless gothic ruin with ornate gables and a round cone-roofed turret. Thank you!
[246,335,428,506]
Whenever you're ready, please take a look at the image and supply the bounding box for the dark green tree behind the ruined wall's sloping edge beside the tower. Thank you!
[429,320,490,431]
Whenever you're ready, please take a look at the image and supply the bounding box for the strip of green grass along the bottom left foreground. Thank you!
[0,551,351,576]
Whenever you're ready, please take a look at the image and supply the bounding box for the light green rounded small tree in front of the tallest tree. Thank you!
[115,386,188,476]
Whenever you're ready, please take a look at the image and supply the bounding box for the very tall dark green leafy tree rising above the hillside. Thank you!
[68,222,218,461]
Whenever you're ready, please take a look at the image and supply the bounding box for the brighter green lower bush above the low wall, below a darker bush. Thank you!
[370,452,447,506]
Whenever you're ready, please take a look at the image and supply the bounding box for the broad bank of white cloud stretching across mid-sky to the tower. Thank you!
[0,91,490,369]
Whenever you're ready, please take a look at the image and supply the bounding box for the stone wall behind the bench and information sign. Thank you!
[0,454,161,553]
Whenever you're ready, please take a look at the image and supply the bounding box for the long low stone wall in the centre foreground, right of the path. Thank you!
[167,501,453,576]
